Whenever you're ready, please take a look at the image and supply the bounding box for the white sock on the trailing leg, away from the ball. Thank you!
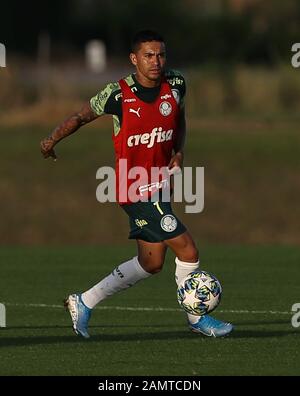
[81,257,152,308]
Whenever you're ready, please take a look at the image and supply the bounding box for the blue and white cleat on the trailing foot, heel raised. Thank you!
[64,294,92,338]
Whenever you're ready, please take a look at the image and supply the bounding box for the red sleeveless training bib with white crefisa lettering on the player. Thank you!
[113,79,179,204]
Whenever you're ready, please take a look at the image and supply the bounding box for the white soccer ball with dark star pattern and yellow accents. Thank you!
[177,271,222,316]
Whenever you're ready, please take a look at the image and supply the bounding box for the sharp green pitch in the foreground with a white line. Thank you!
[0,242,300,376]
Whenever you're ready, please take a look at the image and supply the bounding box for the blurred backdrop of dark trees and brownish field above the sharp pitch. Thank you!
[0,0,300,245]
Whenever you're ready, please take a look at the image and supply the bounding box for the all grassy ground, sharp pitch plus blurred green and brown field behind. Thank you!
[0,119,300,376]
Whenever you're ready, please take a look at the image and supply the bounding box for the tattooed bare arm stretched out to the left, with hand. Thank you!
[40,102,98,160]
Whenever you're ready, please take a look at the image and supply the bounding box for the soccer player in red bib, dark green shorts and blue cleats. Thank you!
[41,30,233,338]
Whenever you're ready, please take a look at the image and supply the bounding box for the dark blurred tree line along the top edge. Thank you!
[0,0,300,65]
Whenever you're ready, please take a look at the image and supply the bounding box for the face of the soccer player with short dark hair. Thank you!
[130,41,166,86]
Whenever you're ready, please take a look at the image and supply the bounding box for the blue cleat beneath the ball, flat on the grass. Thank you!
[189,315,233,337]
